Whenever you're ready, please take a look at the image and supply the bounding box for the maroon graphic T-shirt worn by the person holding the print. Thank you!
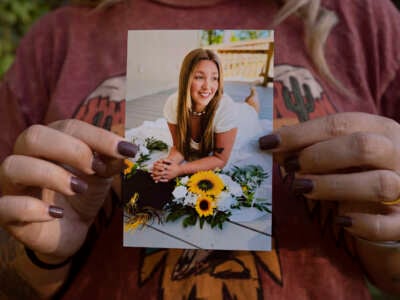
[0,0,400,300]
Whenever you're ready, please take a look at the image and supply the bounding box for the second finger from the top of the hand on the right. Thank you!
[284,132,400,174]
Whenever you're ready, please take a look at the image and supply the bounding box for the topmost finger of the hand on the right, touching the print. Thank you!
[260,112,400,152]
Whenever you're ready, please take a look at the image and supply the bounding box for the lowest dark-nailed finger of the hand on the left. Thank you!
[0,196,63,225]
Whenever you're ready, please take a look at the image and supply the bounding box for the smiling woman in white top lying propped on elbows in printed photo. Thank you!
[152,48,259,182]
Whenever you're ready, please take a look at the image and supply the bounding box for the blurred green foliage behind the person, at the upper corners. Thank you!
[0,0,400,80]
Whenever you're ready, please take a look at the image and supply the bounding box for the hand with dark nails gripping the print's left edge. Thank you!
[0,120,137,263]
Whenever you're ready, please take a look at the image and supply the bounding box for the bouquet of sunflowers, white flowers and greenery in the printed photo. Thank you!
[164,165,268,229]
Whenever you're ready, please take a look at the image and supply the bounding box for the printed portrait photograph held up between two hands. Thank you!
[122,29,274,251]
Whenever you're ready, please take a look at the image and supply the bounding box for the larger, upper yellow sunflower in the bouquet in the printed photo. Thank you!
[188,171,225,197]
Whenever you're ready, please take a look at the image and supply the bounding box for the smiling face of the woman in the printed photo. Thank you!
[190,60,219,112]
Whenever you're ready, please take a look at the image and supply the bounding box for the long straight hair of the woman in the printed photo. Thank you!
[176,48,224,160]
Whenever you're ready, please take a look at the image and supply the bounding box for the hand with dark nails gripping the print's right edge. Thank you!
[260,113,400,241]
